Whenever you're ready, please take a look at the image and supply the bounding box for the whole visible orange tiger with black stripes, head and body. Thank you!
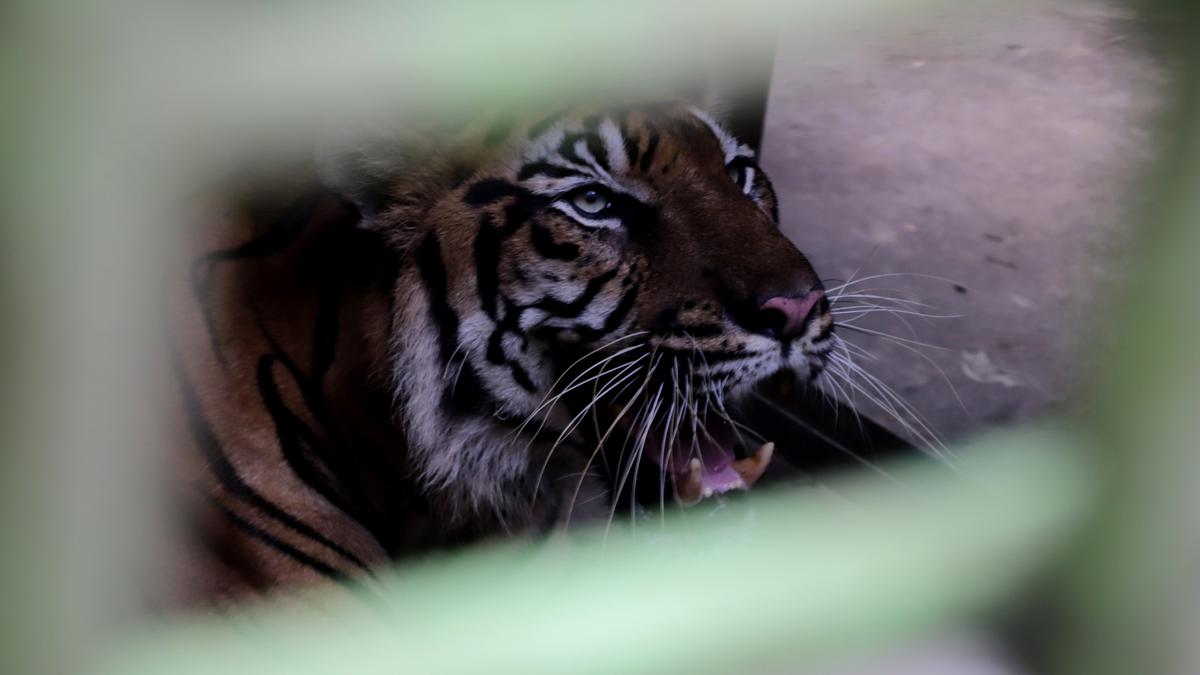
[168,101,834,602]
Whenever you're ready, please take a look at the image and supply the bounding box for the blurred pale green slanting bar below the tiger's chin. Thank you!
[98,431,1091,675]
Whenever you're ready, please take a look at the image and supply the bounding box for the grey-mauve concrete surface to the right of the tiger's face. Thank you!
[763,2,1163,440]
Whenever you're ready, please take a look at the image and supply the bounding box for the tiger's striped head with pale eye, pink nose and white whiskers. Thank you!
[324,103,833,516]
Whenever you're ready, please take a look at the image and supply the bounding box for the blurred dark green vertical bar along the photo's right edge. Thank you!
[1051,0,1200,675]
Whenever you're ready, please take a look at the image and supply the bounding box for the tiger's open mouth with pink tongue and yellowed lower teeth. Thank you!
[624,419,775,506]
